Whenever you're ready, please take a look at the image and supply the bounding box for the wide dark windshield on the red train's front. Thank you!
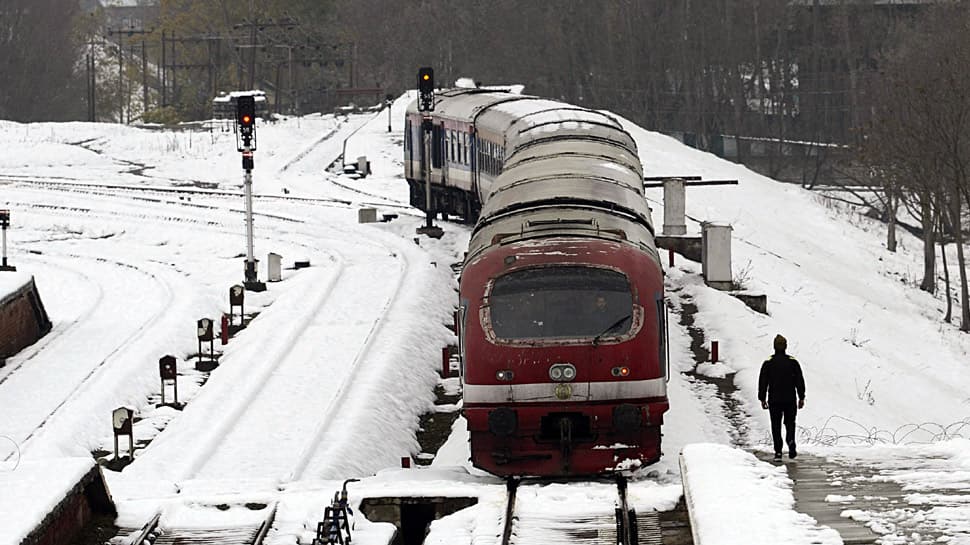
[489,266,633,340]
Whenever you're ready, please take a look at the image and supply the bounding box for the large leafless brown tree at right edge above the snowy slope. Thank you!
[866,4,970,331]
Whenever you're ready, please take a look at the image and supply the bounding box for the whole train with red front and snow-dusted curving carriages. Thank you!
[404,88,669,477]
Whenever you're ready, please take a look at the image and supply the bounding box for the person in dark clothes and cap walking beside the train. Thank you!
[758,335,805,461]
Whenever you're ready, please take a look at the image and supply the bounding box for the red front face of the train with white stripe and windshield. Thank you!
[461,236,668,476]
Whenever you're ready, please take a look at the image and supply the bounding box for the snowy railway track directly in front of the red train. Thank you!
[502,477,664,545]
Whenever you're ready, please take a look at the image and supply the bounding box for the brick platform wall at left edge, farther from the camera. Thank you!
[0,278,51,362]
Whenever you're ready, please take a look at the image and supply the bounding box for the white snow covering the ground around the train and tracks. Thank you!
[0,91,970,545]
